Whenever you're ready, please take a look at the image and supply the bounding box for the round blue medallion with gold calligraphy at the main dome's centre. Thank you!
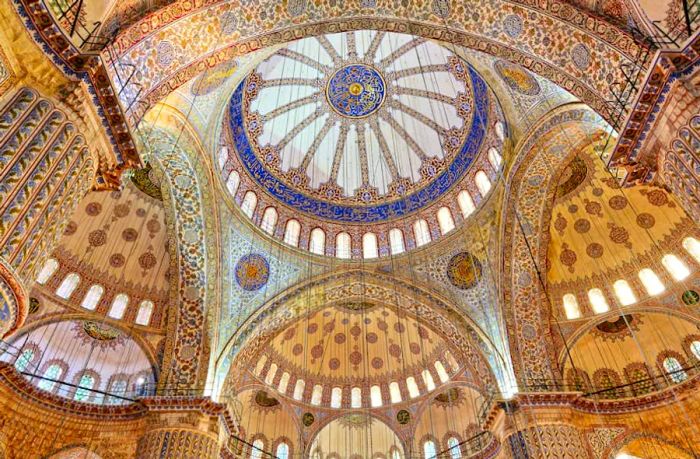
[326,64,386,118]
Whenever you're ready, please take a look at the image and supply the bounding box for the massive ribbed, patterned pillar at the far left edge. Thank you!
[0,87,96,336]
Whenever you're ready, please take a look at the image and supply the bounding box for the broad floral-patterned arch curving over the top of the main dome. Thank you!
[113,0,652,126]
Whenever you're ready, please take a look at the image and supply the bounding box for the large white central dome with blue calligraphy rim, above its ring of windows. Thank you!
[228,31,498,224]
